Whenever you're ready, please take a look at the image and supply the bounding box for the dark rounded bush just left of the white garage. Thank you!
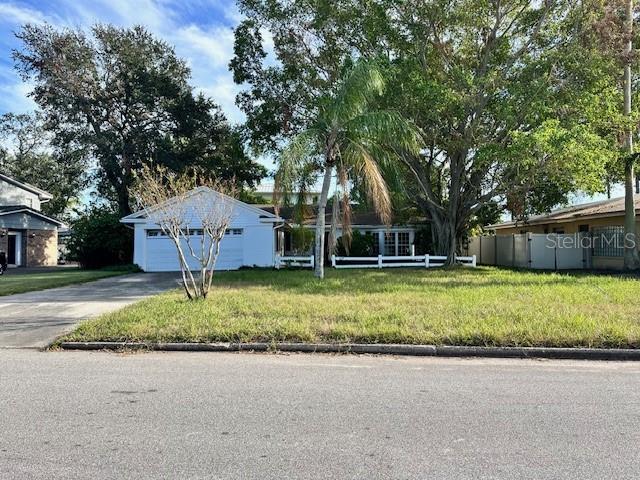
[68,205,133,268]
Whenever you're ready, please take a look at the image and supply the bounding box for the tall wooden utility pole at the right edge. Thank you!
[624,0,640,270]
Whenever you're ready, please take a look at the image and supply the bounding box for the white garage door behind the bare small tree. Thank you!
[146,228,244,272]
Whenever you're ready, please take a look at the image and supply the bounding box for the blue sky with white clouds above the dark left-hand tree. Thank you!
[0,0,255,122]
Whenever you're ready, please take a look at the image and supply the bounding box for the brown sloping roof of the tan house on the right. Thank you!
[486,195,640,230]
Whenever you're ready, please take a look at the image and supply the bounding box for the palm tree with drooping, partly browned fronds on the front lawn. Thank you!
[275,60,420,278]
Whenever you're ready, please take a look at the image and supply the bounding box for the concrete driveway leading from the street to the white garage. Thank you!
[0,273,178,348]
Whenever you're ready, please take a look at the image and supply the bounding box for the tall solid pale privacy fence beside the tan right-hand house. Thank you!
[467,233,591,270]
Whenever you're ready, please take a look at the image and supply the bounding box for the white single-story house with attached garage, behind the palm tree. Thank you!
[121,187,415,272]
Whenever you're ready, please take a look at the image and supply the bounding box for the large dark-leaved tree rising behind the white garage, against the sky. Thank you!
[14,24,265,215]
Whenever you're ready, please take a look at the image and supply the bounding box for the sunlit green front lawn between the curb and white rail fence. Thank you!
[65,268,640,347]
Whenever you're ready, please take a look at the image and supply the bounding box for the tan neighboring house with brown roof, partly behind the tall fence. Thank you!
[485,196,640,269]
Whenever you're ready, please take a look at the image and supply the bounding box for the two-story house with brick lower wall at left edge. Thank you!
[0,173,63,267]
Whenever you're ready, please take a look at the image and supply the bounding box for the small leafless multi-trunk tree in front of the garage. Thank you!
[133,166,235,299]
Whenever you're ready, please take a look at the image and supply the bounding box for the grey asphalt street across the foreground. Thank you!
[0,349,640,480]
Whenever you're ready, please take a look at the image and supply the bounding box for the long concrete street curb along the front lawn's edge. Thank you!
[59,342,640,361]
